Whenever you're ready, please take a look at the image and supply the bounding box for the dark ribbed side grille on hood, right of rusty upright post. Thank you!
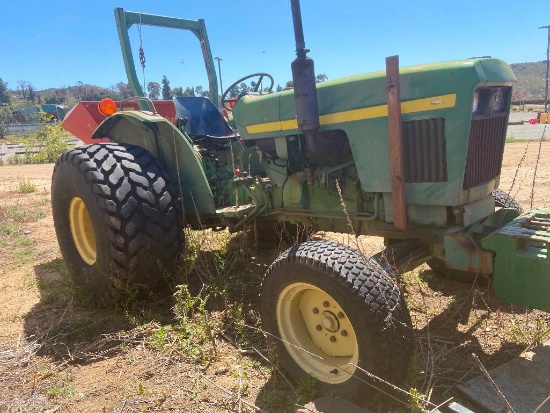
[402,118,447,183]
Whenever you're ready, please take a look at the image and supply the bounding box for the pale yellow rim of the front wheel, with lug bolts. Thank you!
[276,282,359,384]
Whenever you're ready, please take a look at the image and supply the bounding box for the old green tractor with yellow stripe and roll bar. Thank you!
[52,0,550,399]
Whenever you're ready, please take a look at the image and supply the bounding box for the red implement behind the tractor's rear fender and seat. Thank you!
[61,100,176,144]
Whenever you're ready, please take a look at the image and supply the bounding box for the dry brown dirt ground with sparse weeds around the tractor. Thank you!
[0,141,550,413]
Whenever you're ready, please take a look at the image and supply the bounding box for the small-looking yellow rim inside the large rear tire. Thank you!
[69,197,97,265]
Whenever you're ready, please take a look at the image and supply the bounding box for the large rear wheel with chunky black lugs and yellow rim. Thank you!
[52,143,183,304]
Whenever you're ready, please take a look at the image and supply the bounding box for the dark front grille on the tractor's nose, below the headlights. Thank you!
[462,116,507,189]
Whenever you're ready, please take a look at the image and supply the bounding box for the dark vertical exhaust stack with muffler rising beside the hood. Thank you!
[290,0,320,141]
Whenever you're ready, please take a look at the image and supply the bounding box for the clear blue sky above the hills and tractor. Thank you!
[0,0,550,90]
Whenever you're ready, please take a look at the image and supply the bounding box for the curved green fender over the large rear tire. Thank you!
[92,111,216,219]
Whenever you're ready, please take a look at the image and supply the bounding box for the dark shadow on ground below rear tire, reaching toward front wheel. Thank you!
[24,229,278,364]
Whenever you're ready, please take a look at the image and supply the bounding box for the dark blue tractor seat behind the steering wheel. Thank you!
[174,96,235,139]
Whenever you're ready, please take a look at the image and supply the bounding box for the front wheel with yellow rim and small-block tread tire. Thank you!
[261,241,412,400]
